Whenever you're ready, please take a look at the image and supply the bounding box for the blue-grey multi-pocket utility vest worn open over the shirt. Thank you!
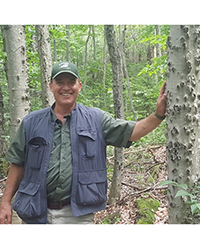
[13,104,107,224]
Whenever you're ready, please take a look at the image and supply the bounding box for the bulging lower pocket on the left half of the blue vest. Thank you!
[13,180,41,219]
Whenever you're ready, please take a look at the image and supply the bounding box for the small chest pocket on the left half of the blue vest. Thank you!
[27,137,46,169]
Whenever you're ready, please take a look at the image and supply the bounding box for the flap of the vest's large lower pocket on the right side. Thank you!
[79,170,107,184]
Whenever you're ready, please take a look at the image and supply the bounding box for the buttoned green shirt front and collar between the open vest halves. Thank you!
[46,110,72,201]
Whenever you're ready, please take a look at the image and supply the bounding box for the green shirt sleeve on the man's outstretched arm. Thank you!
[102,111,136,148]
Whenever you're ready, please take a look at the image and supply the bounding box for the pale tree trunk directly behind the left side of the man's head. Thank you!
[35,25,54,108]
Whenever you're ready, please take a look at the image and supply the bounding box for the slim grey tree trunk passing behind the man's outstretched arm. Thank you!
[105,25,124,204]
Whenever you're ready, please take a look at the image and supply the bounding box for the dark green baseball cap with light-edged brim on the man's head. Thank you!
[51,62,80,79]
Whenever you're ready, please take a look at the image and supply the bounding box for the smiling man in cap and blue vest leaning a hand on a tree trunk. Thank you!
[0,62,166,224]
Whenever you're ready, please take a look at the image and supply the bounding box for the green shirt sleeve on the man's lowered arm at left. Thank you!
[6,122,25,166]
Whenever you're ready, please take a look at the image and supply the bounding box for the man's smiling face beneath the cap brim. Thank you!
[49,73,82,107]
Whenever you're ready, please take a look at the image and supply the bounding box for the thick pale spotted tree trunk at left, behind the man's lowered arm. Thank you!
[1,25,30,140]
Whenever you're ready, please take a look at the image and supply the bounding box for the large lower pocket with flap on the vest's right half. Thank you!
[77,170,107,206]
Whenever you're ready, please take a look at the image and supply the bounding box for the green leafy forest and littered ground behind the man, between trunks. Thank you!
[0,25,169,224]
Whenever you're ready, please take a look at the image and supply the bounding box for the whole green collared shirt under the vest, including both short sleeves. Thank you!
[7,106,135,201]
